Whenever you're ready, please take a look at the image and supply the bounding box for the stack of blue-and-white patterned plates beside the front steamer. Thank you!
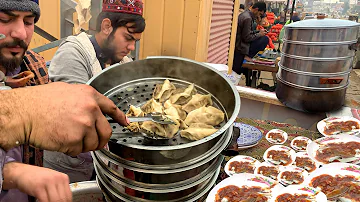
[234,123,263,150]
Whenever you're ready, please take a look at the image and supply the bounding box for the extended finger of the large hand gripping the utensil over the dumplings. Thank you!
[96,92,129,126]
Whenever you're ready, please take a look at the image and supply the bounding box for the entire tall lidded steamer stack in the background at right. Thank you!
[276,16,360,112]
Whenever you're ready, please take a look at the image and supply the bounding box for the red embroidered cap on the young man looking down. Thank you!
[103,0,143,15]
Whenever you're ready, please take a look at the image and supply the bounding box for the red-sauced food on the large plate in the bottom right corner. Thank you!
[310,174,360,202]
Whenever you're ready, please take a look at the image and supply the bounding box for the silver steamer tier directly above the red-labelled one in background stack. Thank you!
[280,54,353,74]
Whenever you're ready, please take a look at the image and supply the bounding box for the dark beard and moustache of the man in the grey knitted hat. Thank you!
[0,40,28,72]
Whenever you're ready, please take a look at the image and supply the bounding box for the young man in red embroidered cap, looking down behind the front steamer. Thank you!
[44,0,145,182]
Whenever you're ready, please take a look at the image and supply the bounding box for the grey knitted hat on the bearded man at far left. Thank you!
[0,0,40,23]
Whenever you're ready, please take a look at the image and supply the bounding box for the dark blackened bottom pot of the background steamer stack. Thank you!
[275,75,347,113]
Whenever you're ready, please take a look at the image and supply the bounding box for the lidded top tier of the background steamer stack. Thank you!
[284,16,359,42]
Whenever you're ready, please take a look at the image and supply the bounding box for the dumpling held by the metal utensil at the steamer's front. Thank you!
[141,116,180,138]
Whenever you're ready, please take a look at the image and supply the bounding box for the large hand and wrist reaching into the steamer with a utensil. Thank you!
[0,82,128,156]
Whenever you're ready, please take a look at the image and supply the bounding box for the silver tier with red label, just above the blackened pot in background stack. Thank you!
[277,64,350,90]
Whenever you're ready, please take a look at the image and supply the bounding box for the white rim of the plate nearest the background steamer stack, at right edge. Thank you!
[317,116,360,136]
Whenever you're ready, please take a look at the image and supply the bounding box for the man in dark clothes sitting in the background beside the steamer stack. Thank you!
[232,2,269,86]
